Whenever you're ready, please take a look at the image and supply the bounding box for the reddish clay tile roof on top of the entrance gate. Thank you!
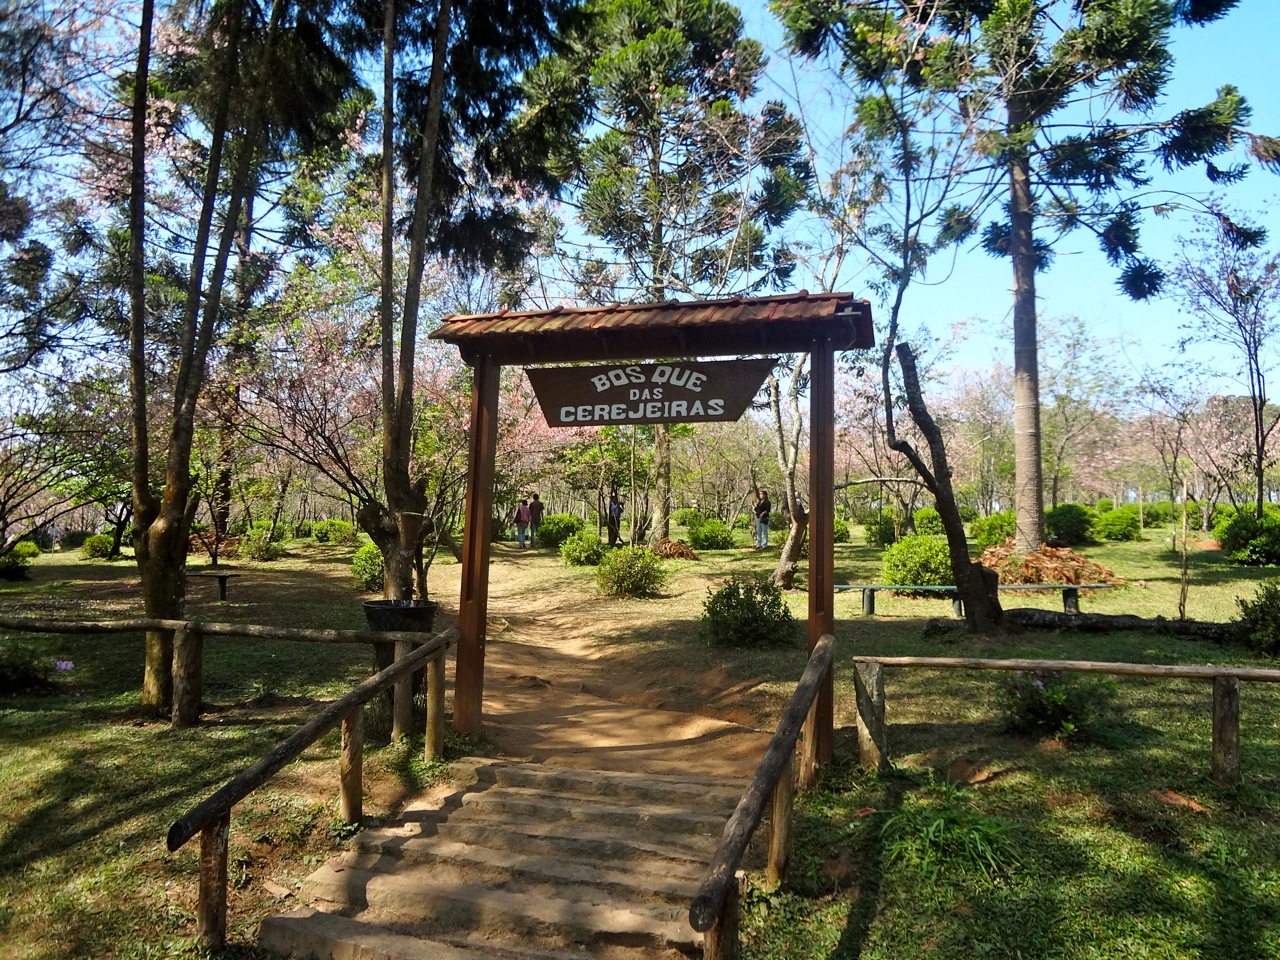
[431,291,874,365]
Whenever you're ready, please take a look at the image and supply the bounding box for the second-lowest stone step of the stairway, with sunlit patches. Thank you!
[301,863,701,950]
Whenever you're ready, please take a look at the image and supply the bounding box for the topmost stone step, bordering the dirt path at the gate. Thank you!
[452,758,749,814]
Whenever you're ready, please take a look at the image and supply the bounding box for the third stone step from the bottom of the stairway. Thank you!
[355,818,719,877]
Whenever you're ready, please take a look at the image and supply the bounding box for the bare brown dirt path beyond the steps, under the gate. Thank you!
[433,567,772,777]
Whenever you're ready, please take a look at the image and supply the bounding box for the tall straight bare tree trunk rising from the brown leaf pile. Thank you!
[1009,95,1044,553]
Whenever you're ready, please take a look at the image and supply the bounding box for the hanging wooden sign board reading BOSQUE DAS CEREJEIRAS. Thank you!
[525,357,777,426]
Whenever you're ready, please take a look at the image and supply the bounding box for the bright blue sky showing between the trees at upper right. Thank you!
[742,0,1280,391]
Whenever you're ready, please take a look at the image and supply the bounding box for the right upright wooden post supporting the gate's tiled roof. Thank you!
[809,337,836,763]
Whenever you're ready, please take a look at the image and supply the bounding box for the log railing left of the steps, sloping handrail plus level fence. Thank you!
[0,617,458,951]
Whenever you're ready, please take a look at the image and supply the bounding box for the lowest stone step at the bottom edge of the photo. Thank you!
[257,908,606,960]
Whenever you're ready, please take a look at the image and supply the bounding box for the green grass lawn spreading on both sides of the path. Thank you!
[0,531,1280,960]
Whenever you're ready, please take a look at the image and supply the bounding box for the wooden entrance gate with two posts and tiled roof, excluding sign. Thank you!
[431,292,874,762]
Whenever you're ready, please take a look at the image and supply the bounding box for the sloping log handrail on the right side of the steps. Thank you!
[689,634,836,960]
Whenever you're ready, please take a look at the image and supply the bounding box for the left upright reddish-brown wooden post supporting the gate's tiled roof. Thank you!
[453,353,502,733]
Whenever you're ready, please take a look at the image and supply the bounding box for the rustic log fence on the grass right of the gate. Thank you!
[852,657,1280,783]
